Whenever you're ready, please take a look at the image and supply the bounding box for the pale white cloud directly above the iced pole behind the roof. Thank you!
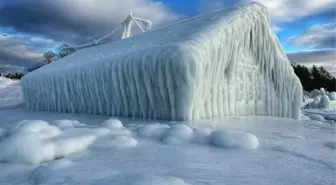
[43,0,178,25]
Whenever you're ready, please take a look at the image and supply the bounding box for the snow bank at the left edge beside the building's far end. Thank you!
[0,76,24,110]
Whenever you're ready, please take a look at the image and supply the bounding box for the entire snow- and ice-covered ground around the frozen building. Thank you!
[0,79,336,185]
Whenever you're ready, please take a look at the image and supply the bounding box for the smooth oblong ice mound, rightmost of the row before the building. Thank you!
[210,131,259,149]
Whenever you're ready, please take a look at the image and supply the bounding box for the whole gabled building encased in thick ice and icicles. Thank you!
[21,3,302,120]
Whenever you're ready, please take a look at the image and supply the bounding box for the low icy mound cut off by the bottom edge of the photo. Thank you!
[93,174,190,185]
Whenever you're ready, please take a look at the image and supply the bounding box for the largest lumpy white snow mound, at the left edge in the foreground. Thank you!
[0,120,137,164]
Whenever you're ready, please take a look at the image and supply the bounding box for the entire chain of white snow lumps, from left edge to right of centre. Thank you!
[0,116,259,164]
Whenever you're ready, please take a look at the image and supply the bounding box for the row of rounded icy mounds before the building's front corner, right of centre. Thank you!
[137,123,259,149]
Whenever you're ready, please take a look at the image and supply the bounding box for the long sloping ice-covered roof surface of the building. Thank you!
[27,3,269,75]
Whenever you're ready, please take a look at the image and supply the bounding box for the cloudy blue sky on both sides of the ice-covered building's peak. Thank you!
[0,0,336,73]
